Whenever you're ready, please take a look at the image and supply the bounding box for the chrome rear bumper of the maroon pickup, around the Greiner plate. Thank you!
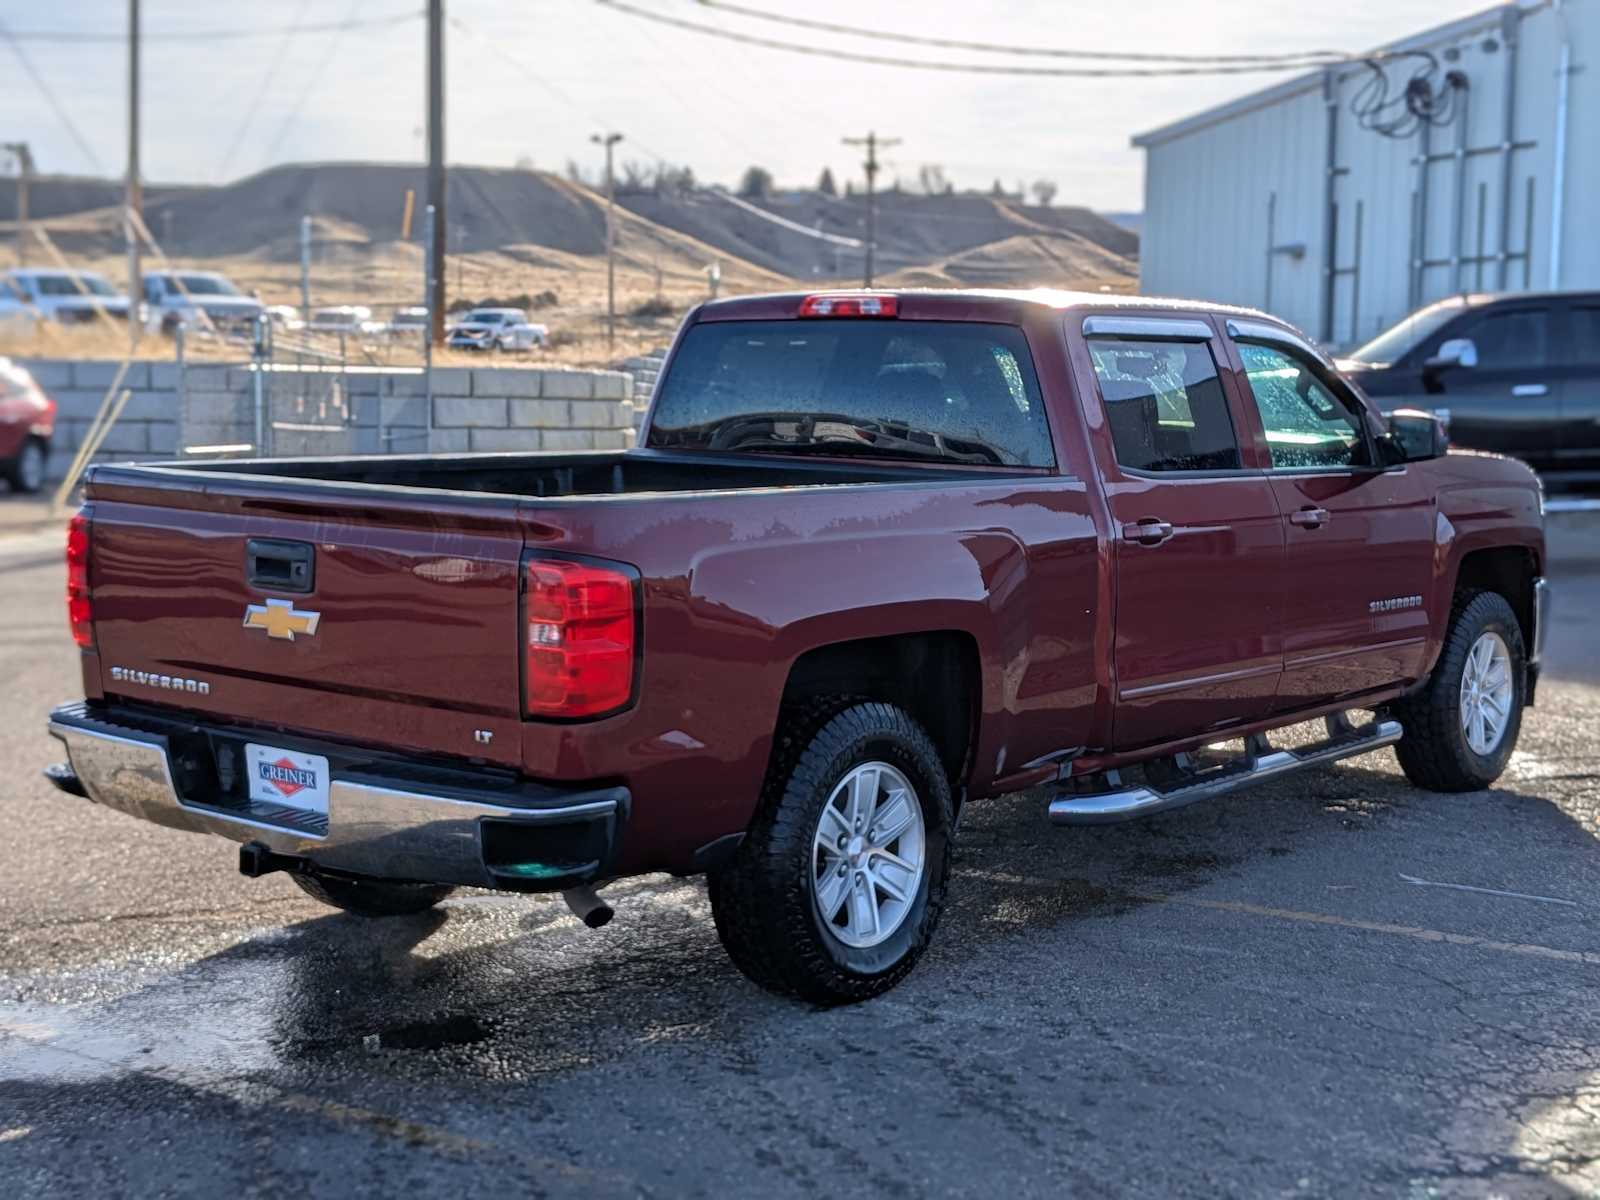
[46,704,629,891]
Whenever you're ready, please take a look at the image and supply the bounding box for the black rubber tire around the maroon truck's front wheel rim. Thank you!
[1394,590,1526,792]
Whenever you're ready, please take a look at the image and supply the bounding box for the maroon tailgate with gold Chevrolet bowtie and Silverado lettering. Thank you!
[88,480,522,765]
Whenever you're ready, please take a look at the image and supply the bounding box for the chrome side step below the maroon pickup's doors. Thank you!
[1050,714,1402,826]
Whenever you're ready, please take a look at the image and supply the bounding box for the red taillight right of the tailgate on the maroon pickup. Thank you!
[522,558,638,717]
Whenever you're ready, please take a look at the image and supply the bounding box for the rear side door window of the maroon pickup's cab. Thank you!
[1088,338,1240,472]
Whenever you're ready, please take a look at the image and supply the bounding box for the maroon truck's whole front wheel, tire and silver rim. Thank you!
[1395,592,1526,792]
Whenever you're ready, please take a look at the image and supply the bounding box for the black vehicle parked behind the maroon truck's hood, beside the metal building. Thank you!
[1339,291,1600,472]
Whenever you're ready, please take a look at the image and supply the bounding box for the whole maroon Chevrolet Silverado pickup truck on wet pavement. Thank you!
[46,291,1549,1003]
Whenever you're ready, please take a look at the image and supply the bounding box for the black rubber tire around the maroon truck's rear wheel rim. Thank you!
[709,699,954,1005]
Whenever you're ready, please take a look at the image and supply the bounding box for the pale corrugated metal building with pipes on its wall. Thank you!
[1133,0,1600,347]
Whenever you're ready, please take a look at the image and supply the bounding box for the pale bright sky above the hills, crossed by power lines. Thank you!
[0,0,1485,210]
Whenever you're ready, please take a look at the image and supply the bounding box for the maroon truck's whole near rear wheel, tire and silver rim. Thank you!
[710,702,954,1005]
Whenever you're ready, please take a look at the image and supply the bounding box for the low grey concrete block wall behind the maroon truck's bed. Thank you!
[22,360,637,478]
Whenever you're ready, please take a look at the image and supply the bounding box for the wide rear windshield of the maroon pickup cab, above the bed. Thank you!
[648,318,1056,467]
